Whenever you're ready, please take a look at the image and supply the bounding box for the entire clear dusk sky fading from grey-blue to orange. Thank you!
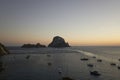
[0,0,120,46]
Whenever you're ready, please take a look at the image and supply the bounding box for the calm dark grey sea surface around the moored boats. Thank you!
[0,46,120,80]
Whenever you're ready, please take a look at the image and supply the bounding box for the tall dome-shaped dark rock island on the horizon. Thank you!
[48,36,70,48]
